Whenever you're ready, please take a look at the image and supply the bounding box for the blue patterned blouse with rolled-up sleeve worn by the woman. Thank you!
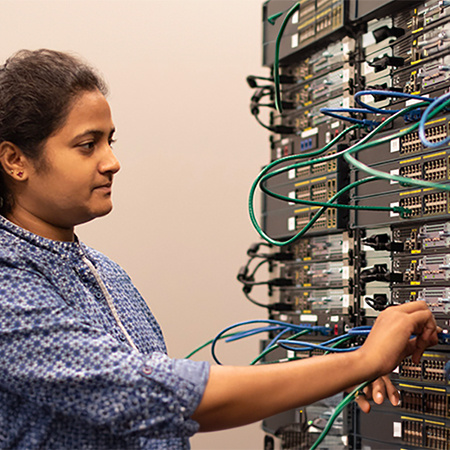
[0,216,209,450]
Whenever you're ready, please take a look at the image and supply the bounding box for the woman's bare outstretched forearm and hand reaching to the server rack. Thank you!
[192,302,438,431]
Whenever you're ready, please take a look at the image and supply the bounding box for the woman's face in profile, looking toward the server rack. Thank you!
[12,91,120,234]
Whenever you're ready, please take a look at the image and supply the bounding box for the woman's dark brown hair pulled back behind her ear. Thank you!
[0,49,107,214]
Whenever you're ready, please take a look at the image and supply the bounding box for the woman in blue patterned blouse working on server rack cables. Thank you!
[0,50,437,449]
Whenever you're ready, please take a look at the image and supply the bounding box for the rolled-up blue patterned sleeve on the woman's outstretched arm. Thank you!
[0,267,209,438]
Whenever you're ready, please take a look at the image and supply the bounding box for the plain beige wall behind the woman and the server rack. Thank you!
[0,0,268,450]
